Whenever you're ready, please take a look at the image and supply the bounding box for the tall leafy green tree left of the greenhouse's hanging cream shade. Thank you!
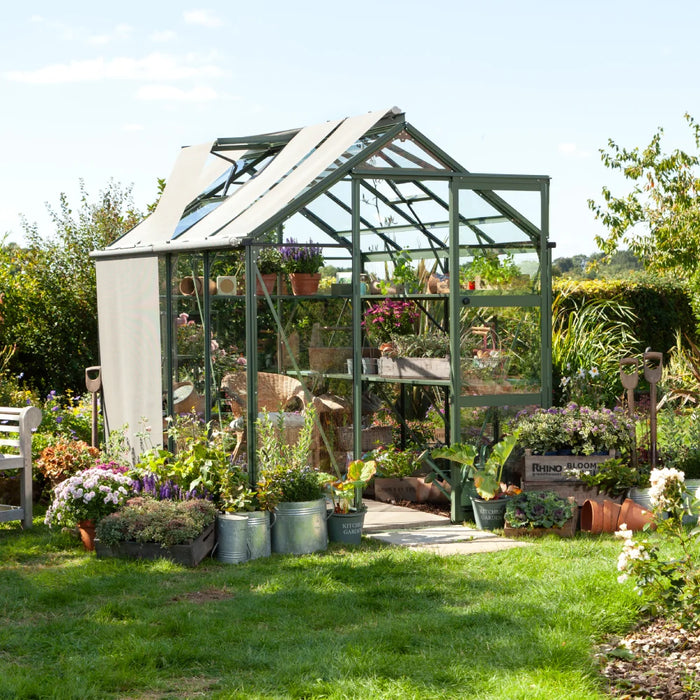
[0,181,142,393]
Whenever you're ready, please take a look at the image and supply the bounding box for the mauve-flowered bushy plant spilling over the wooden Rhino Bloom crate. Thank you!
[516,403,634,455]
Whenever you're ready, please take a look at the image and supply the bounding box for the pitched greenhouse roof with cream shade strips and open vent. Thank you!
[94,107,548,257]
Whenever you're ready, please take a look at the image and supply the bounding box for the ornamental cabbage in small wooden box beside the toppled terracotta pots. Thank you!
[503,491,578,537]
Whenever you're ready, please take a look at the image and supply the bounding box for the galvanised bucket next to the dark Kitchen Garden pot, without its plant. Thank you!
[272,498,328,554]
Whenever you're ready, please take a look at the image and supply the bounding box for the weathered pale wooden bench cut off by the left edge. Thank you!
[0,406,42,528]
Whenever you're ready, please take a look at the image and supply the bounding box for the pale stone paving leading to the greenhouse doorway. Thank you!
[364,499,531,556]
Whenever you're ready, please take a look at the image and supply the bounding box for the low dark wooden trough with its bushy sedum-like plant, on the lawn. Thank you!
[95,496,216,566]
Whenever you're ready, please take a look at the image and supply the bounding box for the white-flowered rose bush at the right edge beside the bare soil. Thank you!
[615,469,700,627]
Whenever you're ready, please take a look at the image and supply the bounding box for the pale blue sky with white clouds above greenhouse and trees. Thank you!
[0,0,700,258]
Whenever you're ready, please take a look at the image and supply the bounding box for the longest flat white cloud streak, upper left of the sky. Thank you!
[5,53,224,85]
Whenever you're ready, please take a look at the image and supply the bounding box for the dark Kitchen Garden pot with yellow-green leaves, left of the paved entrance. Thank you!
[328,459,377,544]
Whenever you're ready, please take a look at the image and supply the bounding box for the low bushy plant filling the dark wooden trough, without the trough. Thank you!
[95,497,216,547]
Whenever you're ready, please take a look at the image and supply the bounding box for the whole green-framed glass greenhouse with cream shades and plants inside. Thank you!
[94,107,552,520]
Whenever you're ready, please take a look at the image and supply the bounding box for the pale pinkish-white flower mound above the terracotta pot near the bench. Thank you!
[44,463,133,525]
